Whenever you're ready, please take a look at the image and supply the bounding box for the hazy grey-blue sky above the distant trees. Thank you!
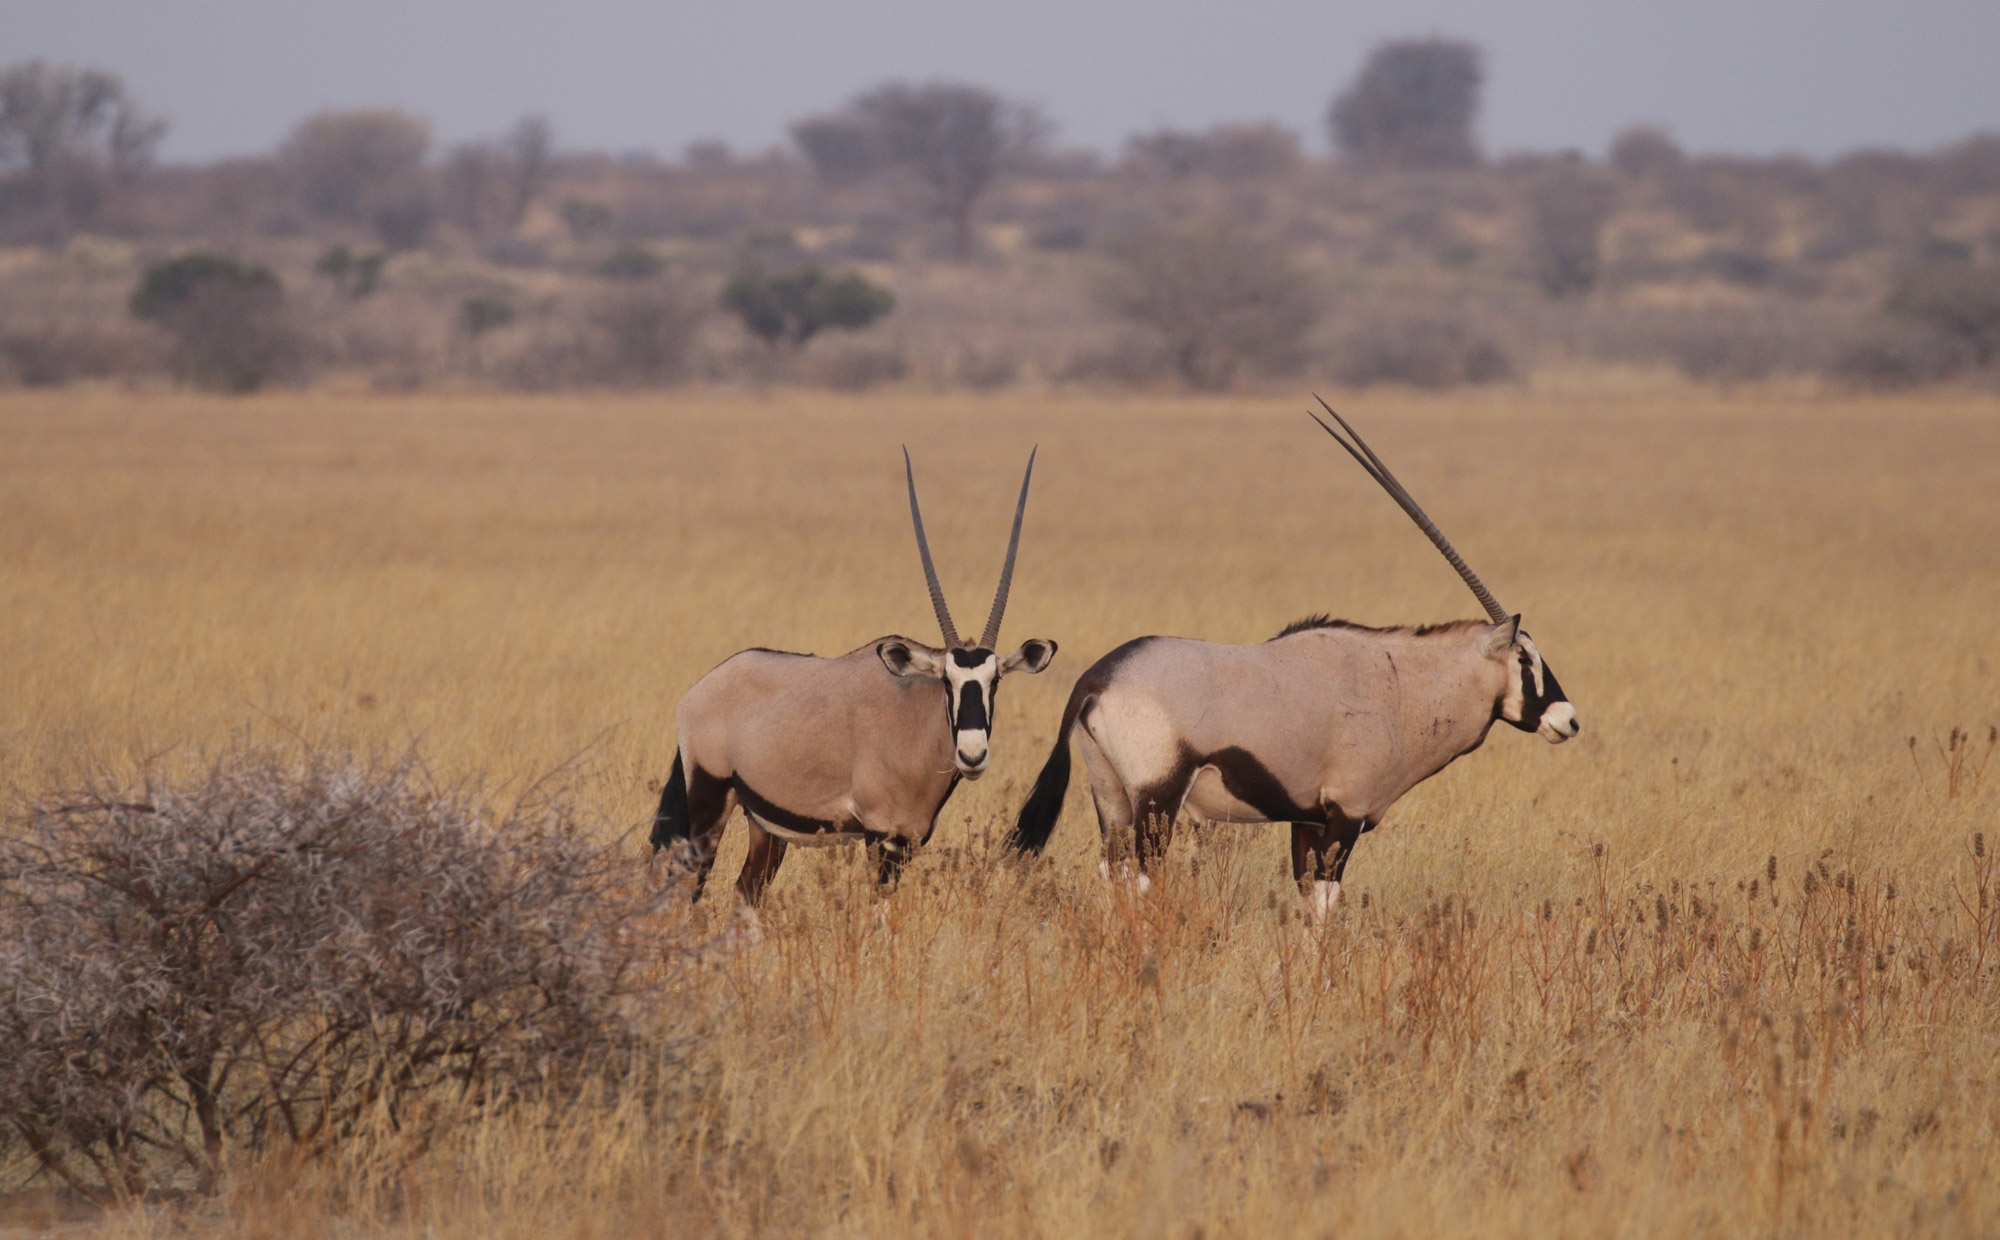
[11,0,2000,160]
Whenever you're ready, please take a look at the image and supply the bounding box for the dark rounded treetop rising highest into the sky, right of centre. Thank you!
[1326,38,1484,168]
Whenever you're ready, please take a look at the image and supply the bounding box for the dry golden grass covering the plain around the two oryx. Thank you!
[0,374,2000,1236]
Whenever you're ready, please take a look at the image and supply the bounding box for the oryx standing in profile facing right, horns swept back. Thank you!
[1012,400,1578,918]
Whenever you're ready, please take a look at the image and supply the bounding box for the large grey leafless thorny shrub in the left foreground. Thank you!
[0,754,666,1202]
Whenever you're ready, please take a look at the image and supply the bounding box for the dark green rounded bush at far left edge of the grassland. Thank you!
[130,250,298,392]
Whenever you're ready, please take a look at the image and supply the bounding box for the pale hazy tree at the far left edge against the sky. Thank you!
[0,60,166,246]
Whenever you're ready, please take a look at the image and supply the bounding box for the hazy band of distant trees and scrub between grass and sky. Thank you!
[0,38,2000,390]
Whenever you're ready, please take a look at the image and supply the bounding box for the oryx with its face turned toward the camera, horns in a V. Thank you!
[652,448,1056,904]
